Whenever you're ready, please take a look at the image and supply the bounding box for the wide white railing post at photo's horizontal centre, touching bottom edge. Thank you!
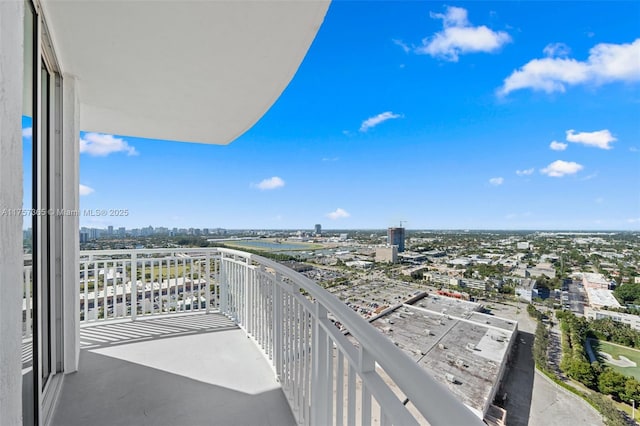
[311,301,333,425]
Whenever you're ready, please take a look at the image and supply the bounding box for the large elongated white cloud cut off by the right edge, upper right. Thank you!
[498,38,640,96]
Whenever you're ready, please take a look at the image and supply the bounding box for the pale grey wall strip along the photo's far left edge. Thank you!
[0,1,24,426]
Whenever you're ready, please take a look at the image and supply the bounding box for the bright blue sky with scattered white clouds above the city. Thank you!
[25,1,640,230]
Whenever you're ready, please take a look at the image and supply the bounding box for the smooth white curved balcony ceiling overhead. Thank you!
[42,0,329,144]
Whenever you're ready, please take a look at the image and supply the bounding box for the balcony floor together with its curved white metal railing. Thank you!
[23,248,481,425]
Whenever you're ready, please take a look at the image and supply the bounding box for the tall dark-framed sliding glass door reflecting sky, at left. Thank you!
[22,0,64,426]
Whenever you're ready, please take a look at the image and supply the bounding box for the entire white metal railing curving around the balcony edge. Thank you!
[20,248,483,425]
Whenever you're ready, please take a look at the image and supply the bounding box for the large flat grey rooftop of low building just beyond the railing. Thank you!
[372,296,517,417]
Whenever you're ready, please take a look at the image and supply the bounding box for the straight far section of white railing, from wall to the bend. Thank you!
[80,249,219,321]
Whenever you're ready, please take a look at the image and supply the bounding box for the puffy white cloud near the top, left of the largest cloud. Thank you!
[414,6,511,62]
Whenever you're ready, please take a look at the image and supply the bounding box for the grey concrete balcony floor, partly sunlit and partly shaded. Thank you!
[52,314,296,426]
